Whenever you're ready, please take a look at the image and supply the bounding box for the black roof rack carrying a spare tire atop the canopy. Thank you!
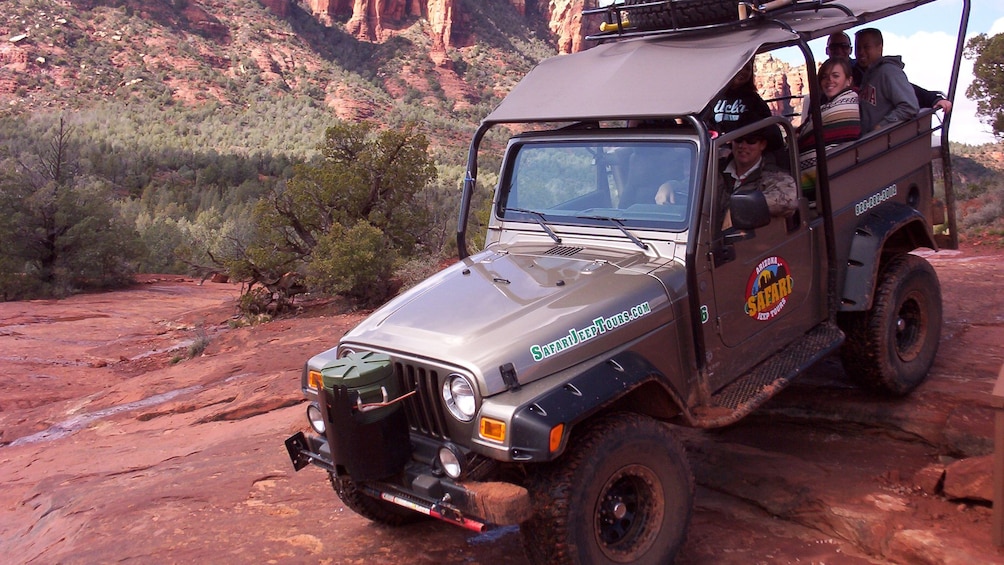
[582,0,853,41]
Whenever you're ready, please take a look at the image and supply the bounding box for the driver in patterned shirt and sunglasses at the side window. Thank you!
[721,129,798,229]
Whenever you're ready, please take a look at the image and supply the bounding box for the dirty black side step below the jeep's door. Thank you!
[690,321,843,428]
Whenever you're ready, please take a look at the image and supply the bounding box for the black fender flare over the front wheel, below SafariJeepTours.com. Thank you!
[509,351,683,462]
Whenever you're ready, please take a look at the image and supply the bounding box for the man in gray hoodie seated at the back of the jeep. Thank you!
[854,27,920,134]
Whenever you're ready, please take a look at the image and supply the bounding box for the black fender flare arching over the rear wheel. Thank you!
[839,202,938,312]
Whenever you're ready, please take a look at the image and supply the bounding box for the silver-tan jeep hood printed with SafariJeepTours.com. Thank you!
[342,248,684,396]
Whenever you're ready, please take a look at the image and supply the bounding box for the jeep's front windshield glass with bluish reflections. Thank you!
[496,139,697,231]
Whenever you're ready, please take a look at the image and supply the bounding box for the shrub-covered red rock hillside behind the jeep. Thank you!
[0,0,1002,312]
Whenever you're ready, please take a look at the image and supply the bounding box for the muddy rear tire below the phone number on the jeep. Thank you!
[840,254,942,396]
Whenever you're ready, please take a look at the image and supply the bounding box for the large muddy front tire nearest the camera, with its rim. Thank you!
[520,413,694,565]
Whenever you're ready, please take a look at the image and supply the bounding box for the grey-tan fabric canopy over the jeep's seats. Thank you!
[484,0,947,123]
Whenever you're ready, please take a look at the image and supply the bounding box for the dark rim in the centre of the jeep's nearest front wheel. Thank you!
[595,465,666,563]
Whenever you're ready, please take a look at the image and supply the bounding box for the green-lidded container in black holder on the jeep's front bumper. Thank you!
[317,351,412,481]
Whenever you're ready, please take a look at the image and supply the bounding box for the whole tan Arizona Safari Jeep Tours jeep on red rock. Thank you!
[286,0,969,564]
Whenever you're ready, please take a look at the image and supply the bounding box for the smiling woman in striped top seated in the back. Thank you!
[798,57,861,193]
